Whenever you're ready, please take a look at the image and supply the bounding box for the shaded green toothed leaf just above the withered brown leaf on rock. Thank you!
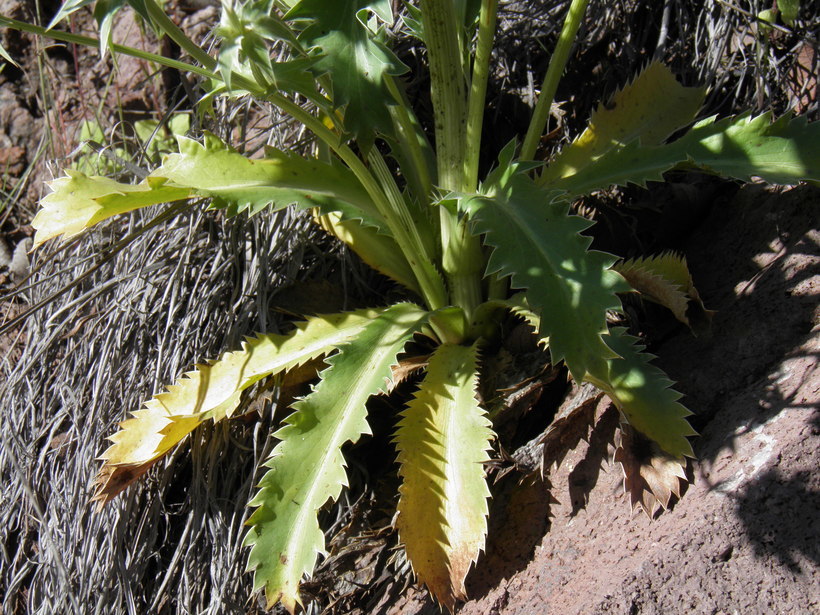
[587,328,697,460]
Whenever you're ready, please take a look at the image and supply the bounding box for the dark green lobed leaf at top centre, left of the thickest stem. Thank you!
[285,0,406,142]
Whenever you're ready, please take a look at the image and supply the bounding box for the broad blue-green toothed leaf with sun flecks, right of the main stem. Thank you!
[459,150,629,382]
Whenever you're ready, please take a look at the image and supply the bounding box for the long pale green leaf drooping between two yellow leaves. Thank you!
[245,303,427,613]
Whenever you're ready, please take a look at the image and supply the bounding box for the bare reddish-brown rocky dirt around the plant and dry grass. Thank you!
[0,0,820,615]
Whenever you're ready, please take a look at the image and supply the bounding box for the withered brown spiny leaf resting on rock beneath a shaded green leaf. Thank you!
[615,423,688,518]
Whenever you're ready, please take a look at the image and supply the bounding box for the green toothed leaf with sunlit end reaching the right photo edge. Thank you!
[545,113,820,195]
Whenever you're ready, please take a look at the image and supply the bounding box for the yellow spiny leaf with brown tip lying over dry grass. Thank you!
[95,310,378,504]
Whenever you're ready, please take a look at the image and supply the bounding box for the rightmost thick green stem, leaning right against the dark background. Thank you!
[520,0,589,160]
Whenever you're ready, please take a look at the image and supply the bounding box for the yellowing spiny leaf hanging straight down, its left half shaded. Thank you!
[396,344,493,611]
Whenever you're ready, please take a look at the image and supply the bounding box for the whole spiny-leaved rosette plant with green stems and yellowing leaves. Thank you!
[0,0,820,612]
